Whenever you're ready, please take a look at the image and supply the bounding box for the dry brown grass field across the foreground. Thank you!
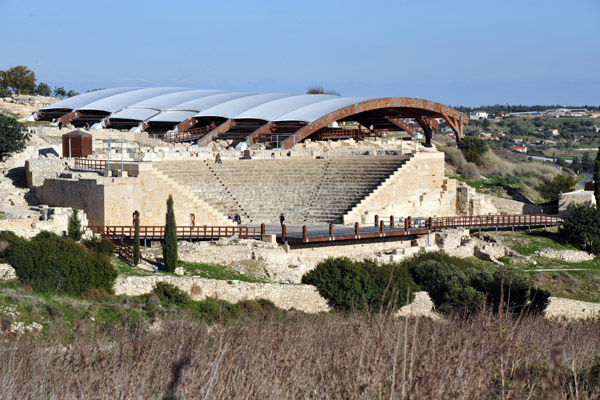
[0,313,600,399]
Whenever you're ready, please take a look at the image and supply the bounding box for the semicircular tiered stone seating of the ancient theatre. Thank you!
[154,156,408,223]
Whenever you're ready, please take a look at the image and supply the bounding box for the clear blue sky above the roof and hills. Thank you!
[0,0,600,106]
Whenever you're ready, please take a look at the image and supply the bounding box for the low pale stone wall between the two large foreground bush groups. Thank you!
[114,275,330,313]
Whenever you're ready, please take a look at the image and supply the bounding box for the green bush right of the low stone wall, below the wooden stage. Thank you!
[302,257,417,311]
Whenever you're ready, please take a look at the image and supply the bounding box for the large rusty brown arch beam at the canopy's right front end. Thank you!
[281,97,469,149]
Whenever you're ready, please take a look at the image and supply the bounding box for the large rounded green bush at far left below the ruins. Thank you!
[6,232,117,295]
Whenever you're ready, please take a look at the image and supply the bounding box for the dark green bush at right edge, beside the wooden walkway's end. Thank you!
[559,205,600,255]
